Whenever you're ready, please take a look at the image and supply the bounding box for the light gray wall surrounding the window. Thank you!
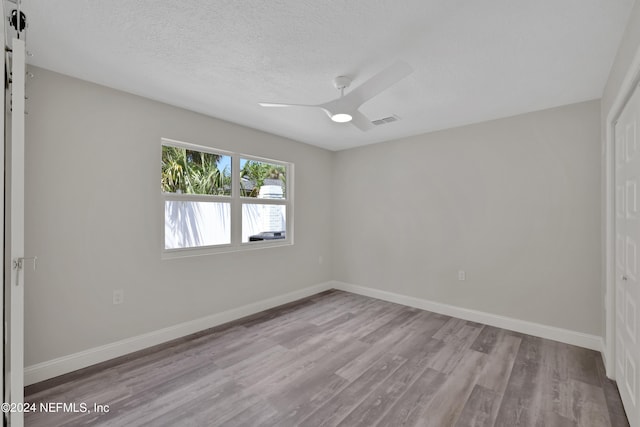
[25,68,332,366]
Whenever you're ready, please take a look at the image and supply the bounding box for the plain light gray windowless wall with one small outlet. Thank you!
[332,100,602,335]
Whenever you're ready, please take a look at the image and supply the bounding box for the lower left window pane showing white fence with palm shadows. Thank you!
[164,200,231,249]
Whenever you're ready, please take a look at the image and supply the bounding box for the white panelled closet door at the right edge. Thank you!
[615,81,640,427]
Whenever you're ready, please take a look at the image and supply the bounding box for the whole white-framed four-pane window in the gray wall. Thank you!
[161,139,293,257]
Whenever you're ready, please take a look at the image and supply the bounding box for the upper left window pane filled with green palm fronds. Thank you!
[162,145,231,196]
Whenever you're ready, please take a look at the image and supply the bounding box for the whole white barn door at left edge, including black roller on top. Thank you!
[3,0,28,427]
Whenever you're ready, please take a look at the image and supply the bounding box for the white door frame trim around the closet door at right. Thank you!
[602,46,640,380]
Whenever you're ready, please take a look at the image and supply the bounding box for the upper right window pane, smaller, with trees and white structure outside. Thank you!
[240,158,287,199]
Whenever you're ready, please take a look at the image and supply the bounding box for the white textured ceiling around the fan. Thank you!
[23,0,634,150]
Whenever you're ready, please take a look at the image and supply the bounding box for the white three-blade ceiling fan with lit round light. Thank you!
[259,61,413,132]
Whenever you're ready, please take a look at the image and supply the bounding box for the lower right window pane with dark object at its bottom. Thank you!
[242,203,287,243]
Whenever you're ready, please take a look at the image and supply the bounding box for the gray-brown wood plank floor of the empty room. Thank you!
[25,291,628,427]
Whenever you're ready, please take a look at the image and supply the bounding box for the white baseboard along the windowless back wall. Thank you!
[331,281,604,352]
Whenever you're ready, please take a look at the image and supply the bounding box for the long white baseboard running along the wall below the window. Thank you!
[24,282,332,385]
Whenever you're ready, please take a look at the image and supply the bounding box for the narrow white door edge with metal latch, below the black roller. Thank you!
[5,39,26,427]
